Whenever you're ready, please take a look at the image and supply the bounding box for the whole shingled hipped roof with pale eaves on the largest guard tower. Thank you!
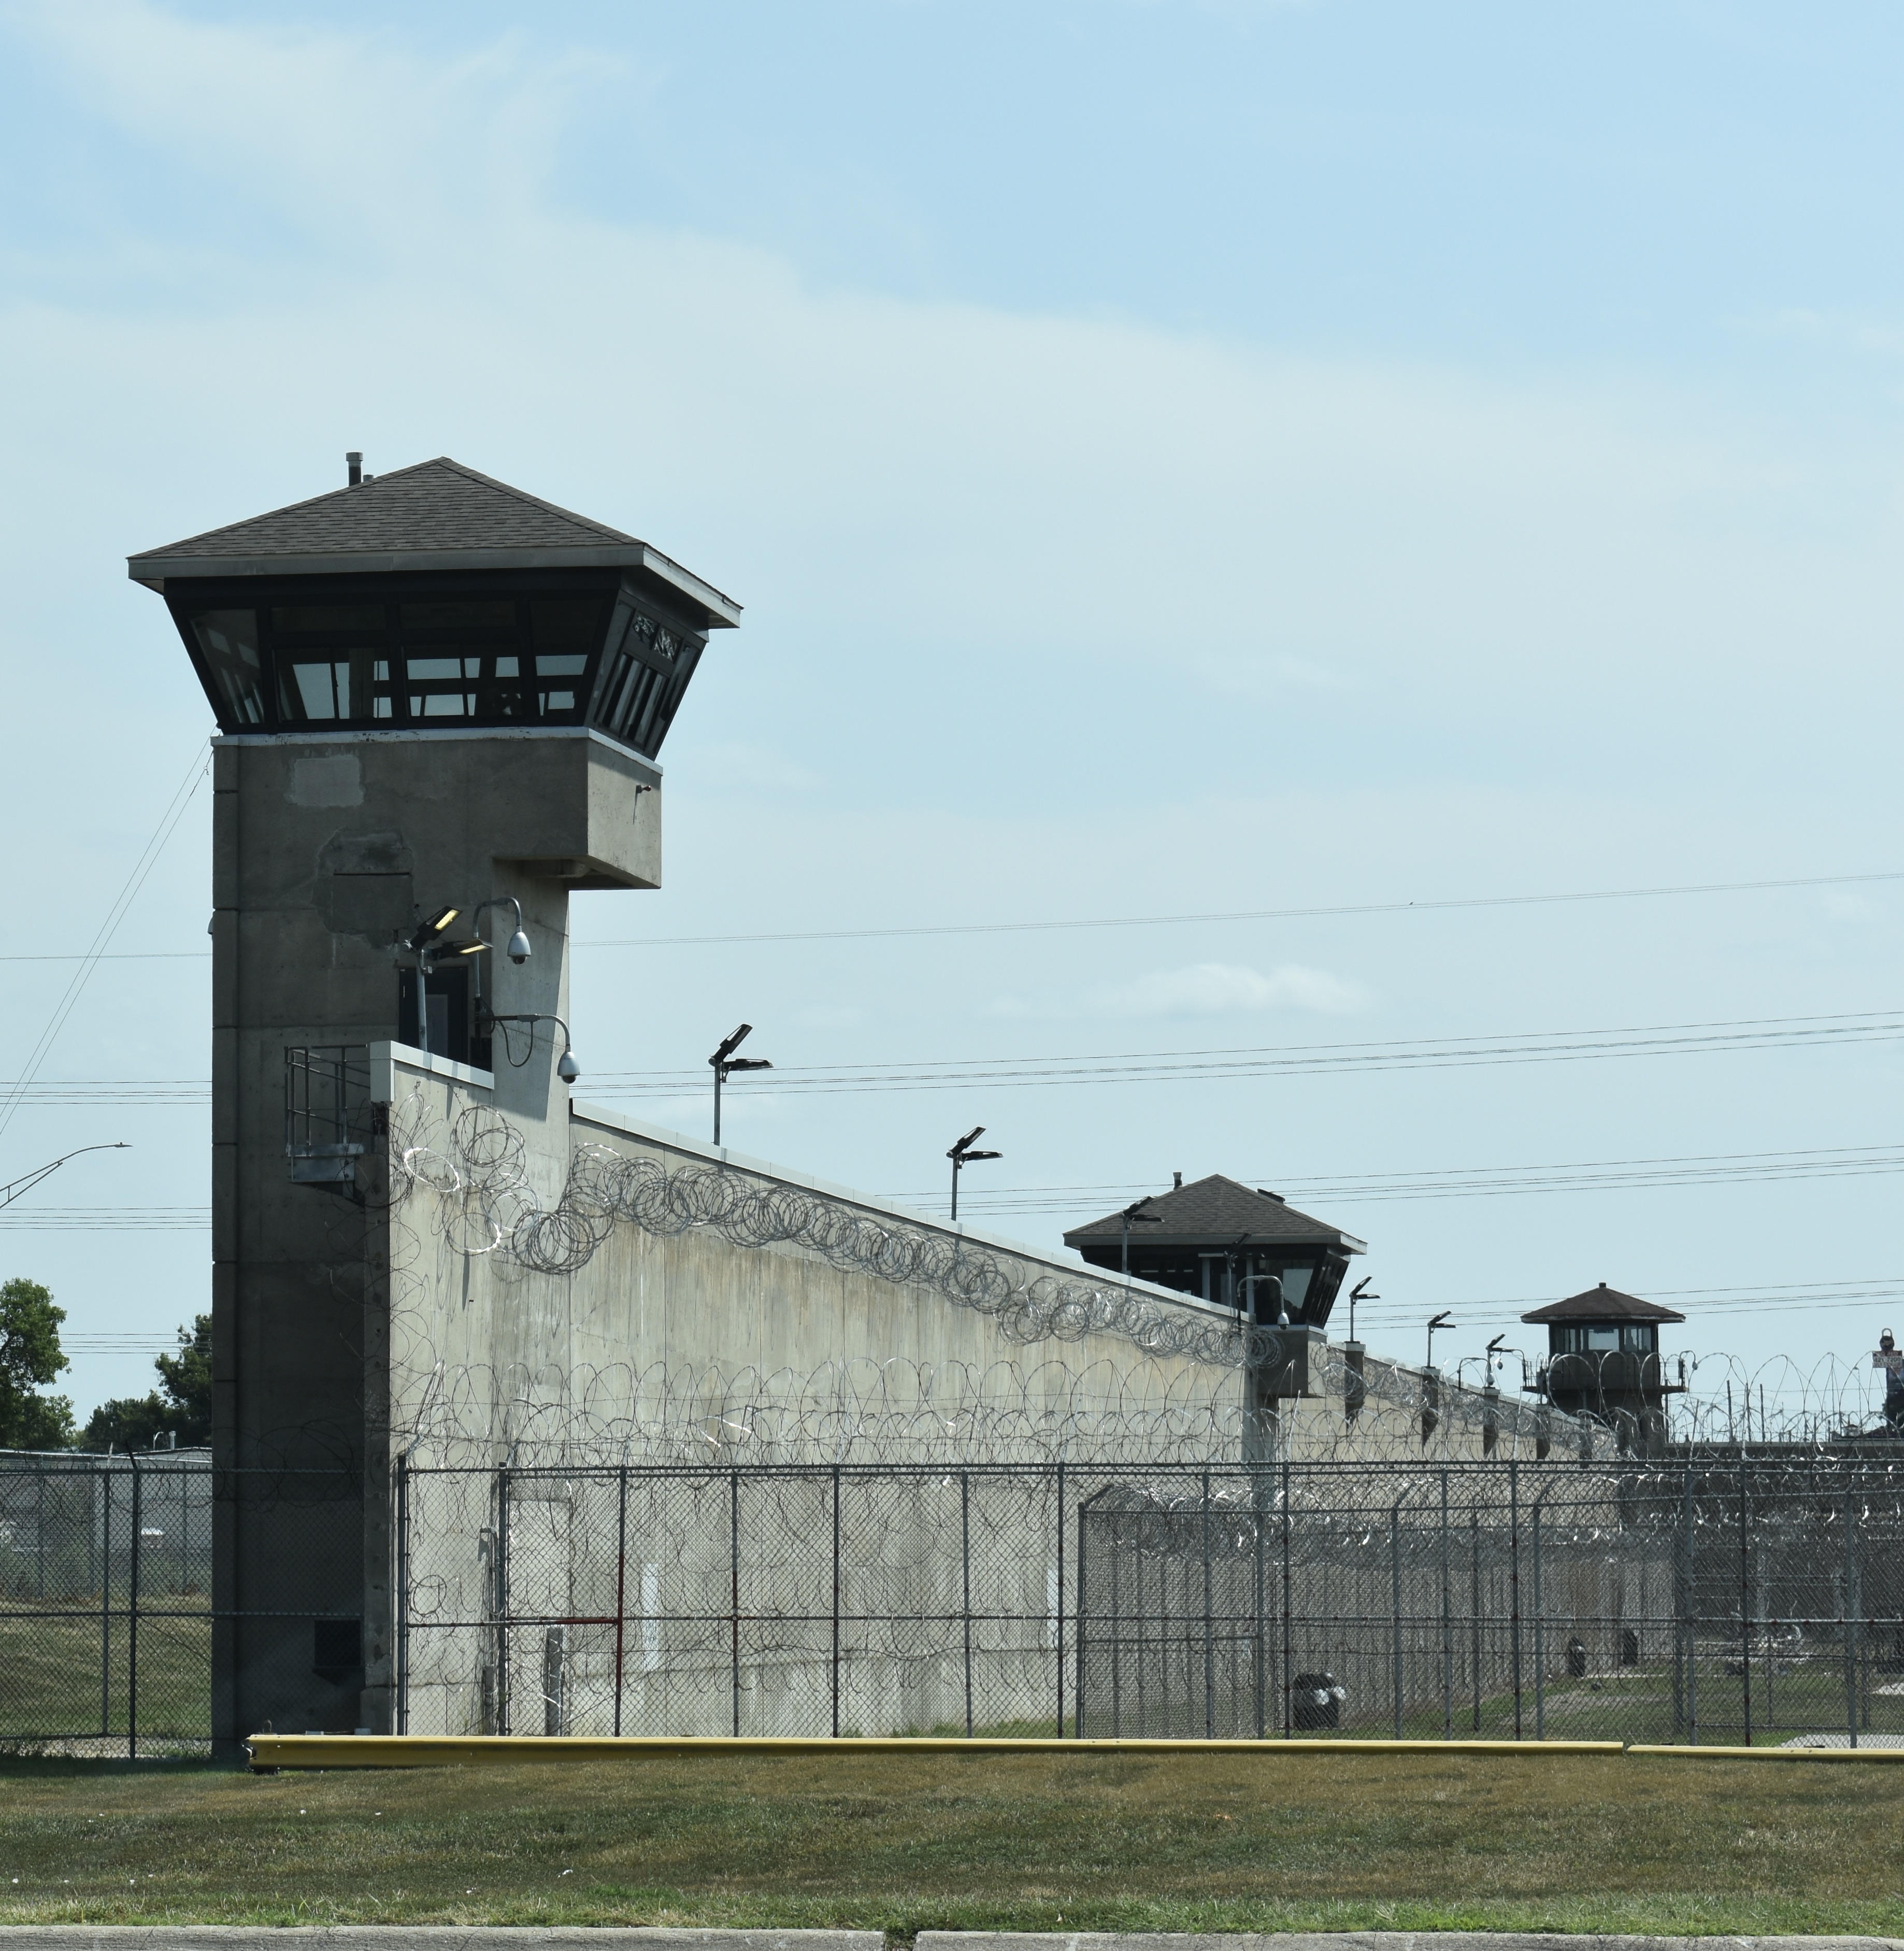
[127,459,741,628]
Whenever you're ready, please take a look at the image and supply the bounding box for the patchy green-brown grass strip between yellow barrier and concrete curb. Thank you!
[0,1750,1904,1938]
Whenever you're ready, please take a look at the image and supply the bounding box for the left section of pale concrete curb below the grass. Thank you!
[0,1924,885,1951]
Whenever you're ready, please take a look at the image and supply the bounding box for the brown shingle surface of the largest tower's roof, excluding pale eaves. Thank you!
[133,459,640,564]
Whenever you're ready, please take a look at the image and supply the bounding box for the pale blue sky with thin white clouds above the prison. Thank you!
[0,0,1904,1436]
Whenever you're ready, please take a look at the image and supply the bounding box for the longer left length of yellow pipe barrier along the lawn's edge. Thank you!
[246,1734,1621,1770]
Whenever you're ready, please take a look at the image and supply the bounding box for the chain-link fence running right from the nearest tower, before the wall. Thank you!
[398,1454,1904,1744]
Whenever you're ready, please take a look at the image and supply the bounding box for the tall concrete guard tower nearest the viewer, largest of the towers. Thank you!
[129,454,739,1754]
